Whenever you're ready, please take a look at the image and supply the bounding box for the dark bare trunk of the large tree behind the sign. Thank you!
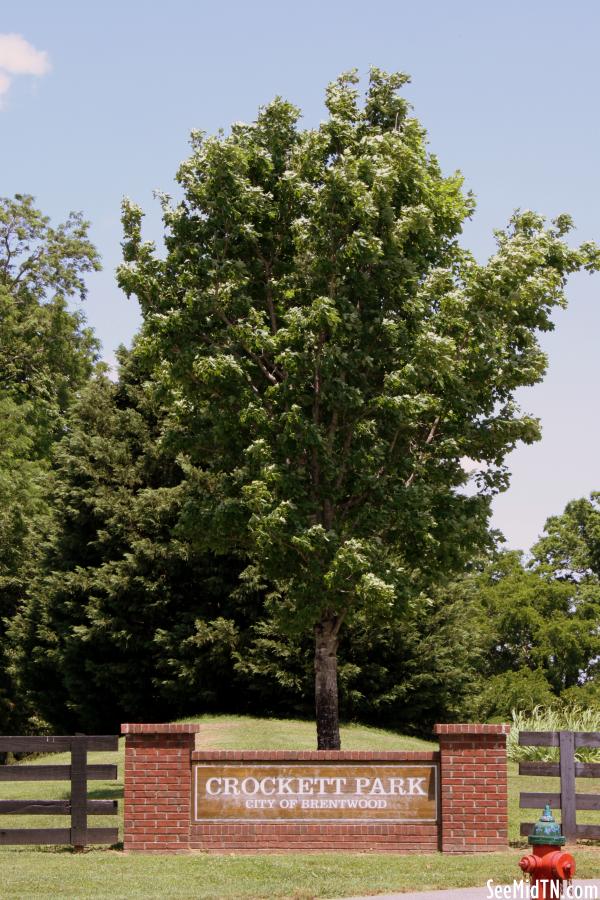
[315,616,341,750]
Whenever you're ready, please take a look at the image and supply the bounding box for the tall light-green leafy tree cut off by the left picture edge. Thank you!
[0,195,99,729]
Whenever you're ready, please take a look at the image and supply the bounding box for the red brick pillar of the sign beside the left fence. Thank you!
[121,723,200,853]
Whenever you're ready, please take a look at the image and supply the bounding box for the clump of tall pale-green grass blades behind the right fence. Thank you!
[506,705,600,762]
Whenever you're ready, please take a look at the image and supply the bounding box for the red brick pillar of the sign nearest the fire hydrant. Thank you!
[434,725,510,853]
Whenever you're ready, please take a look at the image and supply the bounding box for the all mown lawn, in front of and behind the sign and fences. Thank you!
[0,716,600,900]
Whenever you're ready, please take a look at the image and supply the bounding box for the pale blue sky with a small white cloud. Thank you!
[0,0,600,550]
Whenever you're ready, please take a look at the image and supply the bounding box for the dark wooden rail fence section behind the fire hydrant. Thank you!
[519,731,600,841]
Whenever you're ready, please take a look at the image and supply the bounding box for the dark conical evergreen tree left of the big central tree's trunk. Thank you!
[10,350,245,731]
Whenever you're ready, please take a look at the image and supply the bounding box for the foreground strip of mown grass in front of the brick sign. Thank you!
[0,850,600,900]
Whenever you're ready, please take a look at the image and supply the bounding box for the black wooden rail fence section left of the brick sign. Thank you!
[0,734,119,849]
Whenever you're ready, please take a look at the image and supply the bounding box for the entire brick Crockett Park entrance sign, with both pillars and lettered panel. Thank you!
[122,724,508,853]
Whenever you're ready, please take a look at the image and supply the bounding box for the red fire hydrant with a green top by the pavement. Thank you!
[519,804,575,900]
